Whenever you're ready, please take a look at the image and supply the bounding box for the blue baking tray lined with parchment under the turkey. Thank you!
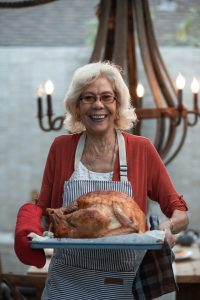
[30,233,164,250]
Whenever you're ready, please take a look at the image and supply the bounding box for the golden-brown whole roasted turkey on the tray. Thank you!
[47,191,146,238]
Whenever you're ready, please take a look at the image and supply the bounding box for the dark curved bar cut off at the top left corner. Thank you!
[0,0,59,9]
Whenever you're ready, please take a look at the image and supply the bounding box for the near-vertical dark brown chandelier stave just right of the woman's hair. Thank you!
[127,0,138,107]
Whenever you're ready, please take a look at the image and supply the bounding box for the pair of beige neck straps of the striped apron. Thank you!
[74,129,128,181]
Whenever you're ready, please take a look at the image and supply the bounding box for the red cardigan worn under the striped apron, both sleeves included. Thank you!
[38,132,188,217]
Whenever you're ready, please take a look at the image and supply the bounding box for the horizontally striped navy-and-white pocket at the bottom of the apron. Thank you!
[42,261,135,300]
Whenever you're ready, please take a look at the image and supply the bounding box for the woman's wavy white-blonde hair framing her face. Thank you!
[64,62,137,133]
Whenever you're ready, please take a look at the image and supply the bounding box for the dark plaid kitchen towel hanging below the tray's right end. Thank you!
[132,243,178,300]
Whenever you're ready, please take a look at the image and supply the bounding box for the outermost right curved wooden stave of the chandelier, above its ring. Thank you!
[143,1,177,96]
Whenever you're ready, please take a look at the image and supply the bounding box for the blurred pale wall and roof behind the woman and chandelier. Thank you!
[0,0,200,273]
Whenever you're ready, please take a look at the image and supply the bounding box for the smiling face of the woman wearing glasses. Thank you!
[79,77,117,134]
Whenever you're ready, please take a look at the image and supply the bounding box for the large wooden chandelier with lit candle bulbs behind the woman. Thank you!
[0,0,200,164]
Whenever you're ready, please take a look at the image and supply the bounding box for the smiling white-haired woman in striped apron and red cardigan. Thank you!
[15,62,188,300]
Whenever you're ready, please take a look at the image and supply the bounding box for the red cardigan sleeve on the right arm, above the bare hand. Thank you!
[146,141,188,217]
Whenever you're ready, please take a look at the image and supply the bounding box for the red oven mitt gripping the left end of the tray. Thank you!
[14,203,46,268]
